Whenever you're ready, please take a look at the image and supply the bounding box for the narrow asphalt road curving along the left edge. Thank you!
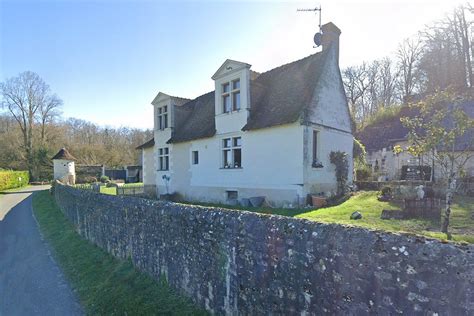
[0,186,83,316]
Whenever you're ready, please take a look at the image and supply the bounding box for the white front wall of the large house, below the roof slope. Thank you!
[167,123,303,205]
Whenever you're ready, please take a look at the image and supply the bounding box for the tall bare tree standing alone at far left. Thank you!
[0,71,60,178]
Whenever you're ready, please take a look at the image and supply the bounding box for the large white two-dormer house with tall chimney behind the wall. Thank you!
[138,23,353,206]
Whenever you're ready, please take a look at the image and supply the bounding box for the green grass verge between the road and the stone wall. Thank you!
[33,191,206,315]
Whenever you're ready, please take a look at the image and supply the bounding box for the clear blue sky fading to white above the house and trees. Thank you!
[0,0,460,128]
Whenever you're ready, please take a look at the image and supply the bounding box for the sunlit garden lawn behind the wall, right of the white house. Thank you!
[296,191,474,243]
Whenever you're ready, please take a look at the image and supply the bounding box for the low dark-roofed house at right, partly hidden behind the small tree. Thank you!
[356,100,474,181]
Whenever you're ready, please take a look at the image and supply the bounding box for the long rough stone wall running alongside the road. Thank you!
[54,185,474,315]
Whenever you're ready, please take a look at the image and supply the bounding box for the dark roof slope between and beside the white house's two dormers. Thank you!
[168,51,327,143]
